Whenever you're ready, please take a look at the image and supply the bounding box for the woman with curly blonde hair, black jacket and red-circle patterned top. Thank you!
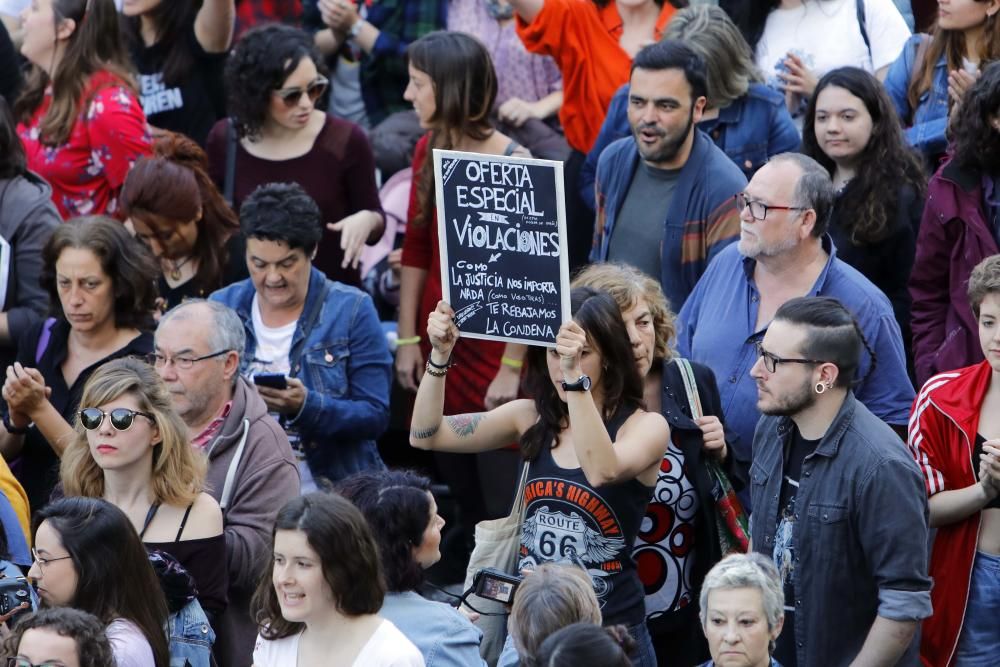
[573,264,741,665]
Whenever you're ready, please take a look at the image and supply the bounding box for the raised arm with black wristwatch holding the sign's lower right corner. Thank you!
[549,321,670,486]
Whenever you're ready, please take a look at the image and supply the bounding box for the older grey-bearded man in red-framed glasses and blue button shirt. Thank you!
[677,153,913,500]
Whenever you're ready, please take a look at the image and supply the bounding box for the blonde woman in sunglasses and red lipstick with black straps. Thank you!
[60,358,228,618]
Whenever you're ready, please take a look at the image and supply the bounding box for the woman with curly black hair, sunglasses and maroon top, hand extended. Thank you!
[208,25,384,287]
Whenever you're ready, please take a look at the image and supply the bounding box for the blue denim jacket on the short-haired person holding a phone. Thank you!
[211,268,392,482]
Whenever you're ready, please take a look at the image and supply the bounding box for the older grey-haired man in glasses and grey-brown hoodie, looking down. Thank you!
[151,299,299,665]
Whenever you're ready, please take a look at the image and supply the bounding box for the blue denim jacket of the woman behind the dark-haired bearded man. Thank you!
[579,83,802,210]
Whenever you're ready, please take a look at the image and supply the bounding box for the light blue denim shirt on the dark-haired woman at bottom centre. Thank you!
[379,591,486,667]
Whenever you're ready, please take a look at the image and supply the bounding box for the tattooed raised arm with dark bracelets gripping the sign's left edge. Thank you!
[410,301,536,452]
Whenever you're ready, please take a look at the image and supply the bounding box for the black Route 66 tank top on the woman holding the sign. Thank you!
[518,406,653,625]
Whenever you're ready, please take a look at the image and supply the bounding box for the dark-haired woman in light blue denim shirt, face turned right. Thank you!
[336,470,485,667]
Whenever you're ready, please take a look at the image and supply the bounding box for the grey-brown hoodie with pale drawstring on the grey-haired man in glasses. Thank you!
[205,377,299,666]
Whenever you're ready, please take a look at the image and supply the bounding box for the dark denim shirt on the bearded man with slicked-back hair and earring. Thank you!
[750,392,931,667]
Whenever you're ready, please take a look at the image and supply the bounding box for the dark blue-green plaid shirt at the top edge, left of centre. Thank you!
[302,0,448,126]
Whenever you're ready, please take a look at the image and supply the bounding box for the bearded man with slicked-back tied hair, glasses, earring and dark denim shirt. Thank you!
[750,297,931,667]
